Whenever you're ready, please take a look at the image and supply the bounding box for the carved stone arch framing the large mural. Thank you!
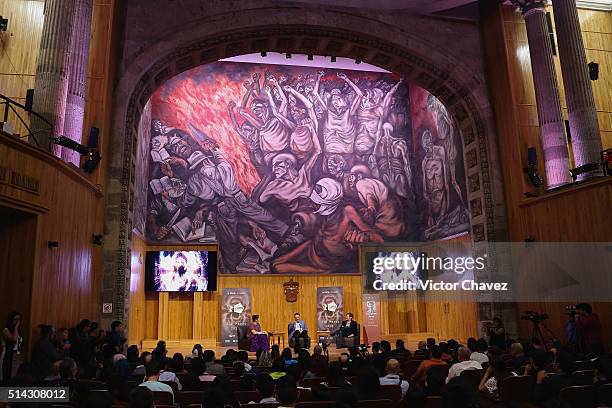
[102,9,505,320]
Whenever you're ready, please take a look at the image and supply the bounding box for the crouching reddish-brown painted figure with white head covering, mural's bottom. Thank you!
[273,178,383,273]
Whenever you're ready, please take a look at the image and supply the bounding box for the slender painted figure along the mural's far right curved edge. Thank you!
[427,94,465,208]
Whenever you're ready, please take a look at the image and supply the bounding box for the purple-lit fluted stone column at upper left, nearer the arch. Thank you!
[62,0,93,167]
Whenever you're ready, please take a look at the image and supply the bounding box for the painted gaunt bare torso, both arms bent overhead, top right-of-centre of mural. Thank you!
[314,71,363,155]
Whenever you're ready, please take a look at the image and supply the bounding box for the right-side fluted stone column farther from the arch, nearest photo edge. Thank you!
[552,0,602,180]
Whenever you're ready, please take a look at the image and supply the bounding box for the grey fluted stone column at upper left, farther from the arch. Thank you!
[30,0,76,156]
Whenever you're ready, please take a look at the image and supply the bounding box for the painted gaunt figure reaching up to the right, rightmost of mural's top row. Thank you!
[355,79,403,162]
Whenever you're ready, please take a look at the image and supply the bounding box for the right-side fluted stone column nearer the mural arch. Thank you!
[513,0,571,189]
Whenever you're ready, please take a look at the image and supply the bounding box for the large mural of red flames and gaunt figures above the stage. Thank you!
[145,62,469,273]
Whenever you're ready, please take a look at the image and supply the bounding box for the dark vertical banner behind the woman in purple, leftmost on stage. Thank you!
[221,288,251,347]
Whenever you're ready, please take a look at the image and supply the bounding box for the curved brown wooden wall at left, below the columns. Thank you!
[0,134,103,348]
